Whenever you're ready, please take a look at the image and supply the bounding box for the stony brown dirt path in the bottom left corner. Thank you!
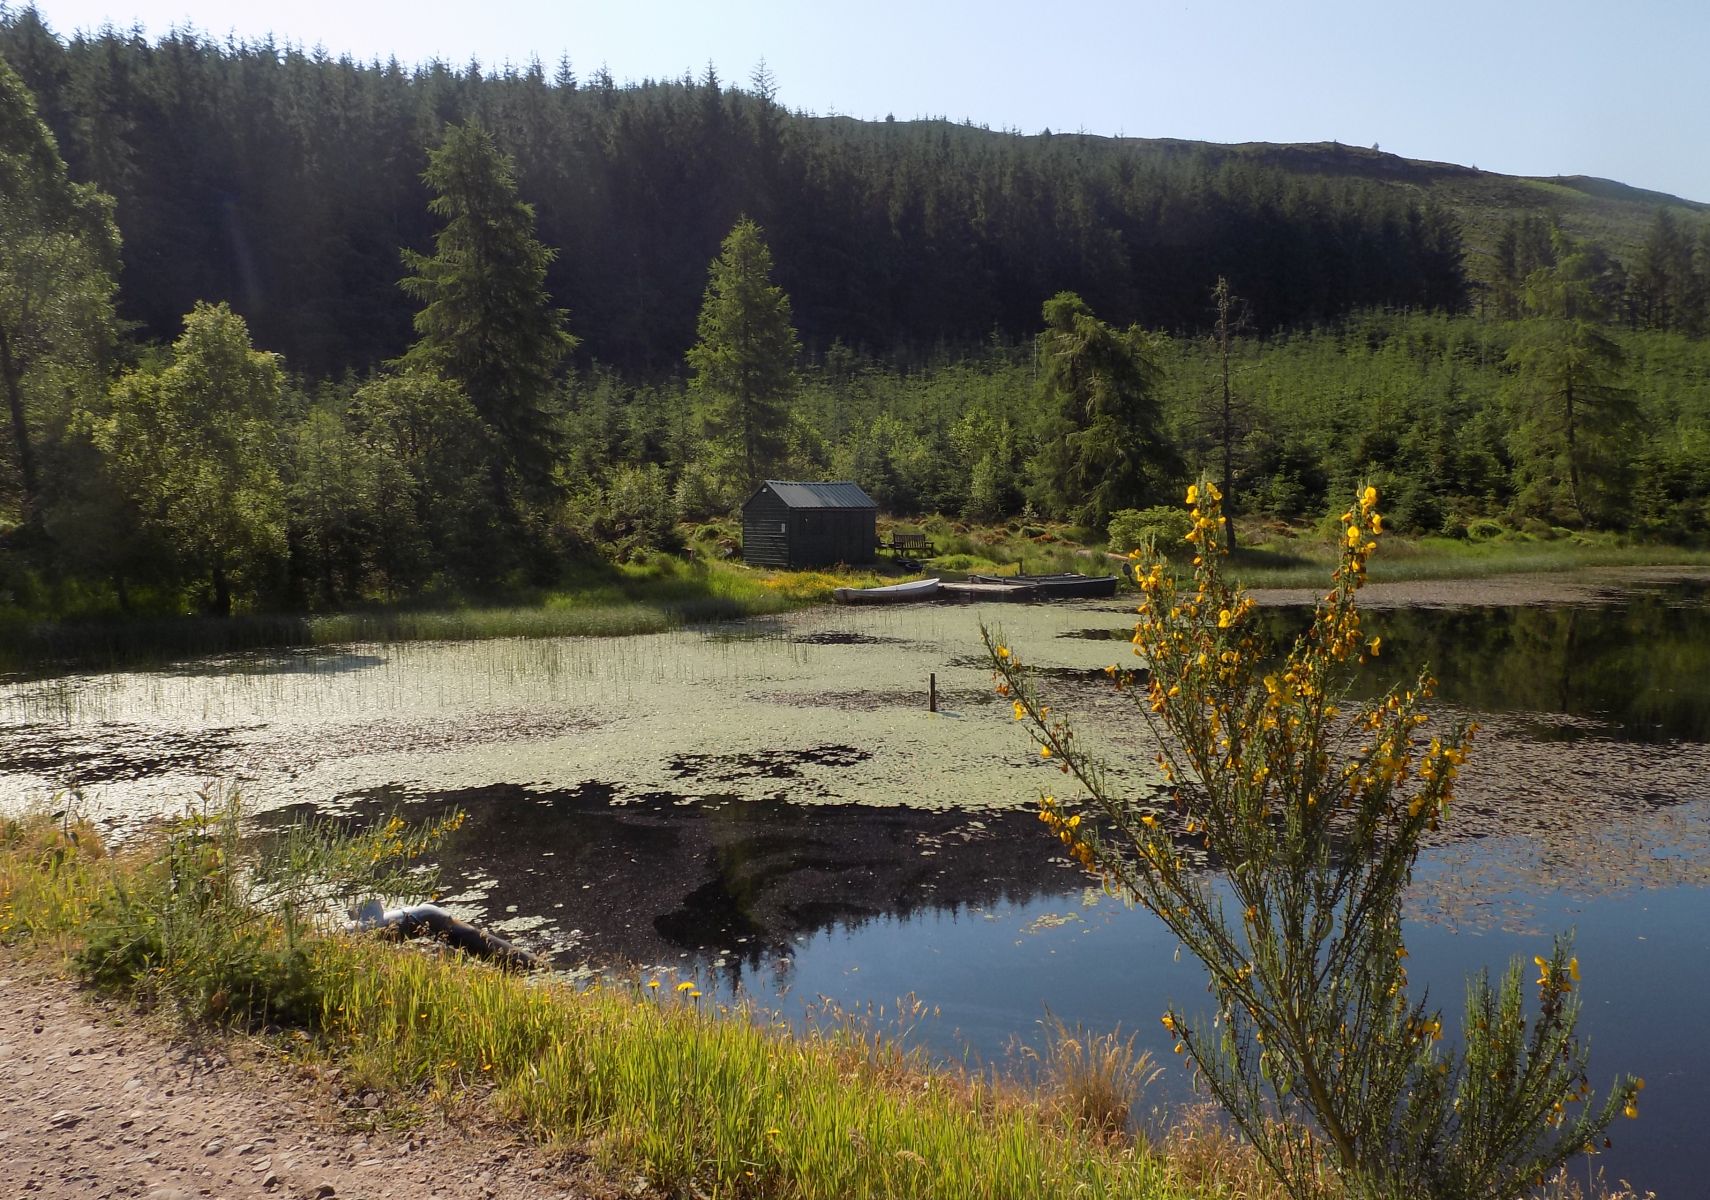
[0,954,636,1200]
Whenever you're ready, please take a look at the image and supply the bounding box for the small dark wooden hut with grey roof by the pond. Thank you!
[742,479,879,568]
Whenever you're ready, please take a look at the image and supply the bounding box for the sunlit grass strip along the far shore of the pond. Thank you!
[0,518,1710,672]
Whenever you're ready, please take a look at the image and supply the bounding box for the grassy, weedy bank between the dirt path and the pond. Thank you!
[0,805,1188,1200]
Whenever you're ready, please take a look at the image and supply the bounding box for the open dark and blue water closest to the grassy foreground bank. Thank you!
[273,783,1710,1195]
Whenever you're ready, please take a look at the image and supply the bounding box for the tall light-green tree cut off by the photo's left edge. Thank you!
[0,60,118,526]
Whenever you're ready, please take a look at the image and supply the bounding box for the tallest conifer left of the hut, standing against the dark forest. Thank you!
[400,121,576,499]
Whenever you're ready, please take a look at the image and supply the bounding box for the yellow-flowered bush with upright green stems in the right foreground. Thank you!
[987,484,1643,1200]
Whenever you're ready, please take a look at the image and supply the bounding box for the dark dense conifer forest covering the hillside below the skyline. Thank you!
[0,9,1464,378]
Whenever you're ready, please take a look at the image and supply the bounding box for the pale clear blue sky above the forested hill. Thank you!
[23,0,1710,202]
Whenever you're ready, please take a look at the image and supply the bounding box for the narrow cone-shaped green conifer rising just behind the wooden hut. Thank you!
[687,217,800,487]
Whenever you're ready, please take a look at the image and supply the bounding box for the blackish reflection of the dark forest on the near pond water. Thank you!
[260,783,1081,986]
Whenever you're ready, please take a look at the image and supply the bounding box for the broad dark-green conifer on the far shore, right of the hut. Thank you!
[1033,292,1182,526]
